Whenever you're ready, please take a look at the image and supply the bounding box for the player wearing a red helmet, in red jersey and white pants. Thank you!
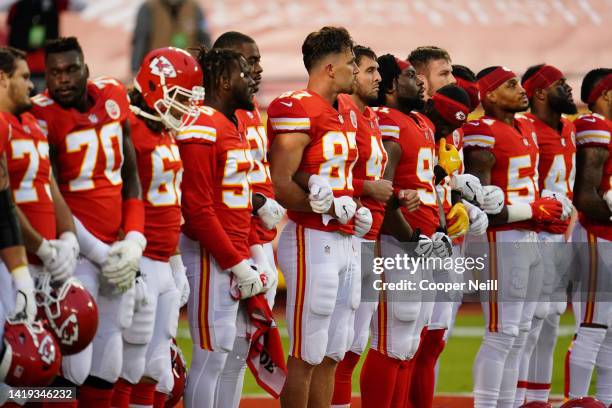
[112,47,204,407]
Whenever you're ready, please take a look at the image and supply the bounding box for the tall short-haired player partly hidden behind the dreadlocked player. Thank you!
[213,31,285,407]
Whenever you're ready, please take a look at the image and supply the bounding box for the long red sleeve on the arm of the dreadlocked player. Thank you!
[180,143,242,269]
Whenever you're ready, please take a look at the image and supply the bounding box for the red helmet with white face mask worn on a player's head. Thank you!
[133,47,204,131]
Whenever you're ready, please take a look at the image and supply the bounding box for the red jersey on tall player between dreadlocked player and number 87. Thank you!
[236,101,276,244]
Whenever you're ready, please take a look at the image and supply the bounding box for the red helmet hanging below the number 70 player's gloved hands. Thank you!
[36,275,98,356]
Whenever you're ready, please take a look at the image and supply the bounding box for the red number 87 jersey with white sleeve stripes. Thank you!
[268,90,358,233]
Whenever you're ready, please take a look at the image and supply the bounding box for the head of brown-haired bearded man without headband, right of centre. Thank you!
[406,45,457,100]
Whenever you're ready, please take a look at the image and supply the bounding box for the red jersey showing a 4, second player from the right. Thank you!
[525,113,576,234]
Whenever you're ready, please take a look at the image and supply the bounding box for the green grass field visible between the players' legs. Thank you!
[177,307,592,395]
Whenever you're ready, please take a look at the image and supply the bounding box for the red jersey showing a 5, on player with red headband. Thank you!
[463,116,540,231]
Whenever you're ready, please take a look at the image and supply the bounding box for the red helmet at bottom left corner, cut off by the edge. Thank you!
[0,321,62,387]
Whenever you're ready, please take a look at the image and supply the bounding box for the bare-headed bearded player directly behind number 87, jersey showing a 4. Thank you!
[332,46,419,407]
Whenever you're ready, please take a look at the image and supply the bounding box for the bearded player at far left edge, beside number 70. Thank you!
[0,48,79,290]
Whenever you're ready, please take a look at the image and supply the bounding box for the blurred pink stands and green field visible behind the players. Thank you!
[0,0,612,408]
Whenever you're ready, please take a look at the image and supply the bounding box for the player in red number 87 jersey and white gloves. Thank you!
[268,27,364,407]
